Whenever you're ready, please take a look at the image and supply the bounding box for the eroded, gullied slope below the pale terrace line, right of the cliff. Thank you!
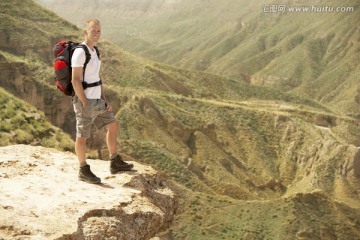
[118,91,360,239]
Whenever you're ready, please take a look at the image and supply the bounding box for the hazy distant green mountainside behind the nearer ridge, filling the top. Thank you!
[38,0,360,114]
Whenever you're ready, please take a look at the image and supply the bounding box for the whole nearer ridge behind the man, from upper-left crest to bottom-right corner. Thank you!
[0,0,360,240]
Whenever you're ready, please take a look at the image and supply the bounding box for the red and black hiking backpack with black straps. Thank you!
[53,41,101,96]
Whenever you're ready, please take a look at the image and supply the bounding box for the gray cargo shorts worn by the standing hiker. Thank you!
[72,96,116,138]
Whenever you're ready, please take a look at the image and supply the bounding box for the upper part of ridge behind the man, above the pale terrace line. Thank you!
[0,0,332,136]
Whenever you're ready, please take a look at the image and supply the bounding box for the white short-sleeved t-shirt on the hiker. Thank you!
[71,42,101,99]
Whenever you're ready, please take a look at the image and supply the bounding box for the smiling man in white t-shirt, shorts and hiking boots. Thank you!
[71,19,133,184]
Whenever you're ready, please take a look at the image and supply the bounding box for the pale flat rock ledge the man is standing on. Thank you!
[0,145,177,240]
